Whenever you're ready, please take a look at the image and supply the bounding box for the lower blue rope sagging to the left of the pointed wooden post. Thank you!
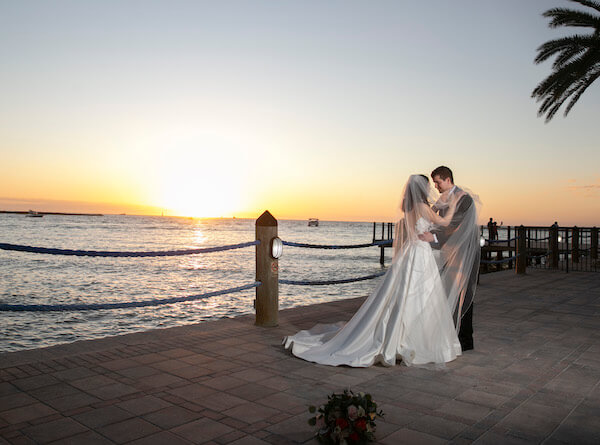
[0,281,261,312]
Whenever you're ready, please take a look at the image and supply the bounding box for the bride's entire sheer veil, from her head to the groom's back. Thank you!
[394,175,481,331]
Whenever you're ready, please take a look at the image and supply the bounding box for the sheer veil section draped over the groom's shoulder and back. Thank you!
[438,183,481,331]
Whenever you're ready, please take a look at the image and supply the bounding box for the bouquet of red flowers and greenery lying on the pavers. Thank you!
[308,389,383,445]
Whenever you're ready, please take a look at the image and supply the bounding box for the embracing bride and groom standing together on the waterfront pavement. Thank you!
[284,166,480,367]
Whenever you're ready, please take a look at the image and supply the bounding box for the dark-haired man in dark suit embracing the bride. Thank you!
[419,166,479,351]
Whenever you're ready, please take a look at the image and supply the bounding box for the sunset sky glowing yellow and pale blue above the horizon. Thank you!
[0,0,600,226]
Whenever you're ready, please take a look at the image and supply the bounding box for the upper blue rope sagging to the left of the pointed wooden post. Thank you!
[0,241,260,257]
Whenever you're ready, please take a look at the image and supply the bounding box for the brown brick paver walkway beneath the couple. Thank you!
[0,271,600,445]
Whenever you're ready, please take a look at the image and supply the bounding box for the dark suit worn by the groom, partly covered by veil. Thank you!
[430,187,479,351]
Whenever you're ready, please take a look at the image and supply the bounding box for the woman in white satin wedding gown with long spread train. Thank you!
[283,175,472,367]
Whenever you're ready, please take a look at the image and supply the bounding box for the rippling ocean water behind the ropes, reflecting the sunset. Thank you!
[0,214,391,352]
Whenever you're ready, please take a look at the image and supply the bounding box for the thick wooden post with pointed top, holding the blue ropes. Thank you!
[255,210,279,326]
